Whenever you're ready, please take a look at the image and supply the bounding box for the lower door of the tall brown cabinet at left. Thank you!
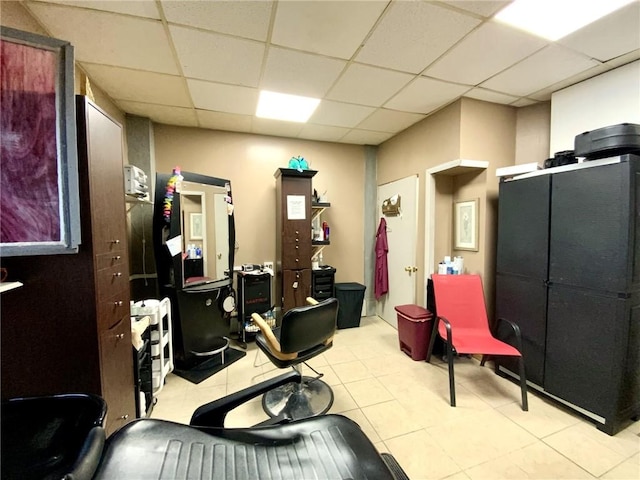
[100,315,136,435]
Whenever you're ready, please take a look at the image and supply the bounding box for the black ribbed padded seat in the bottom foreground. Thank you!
[95,415,398,480]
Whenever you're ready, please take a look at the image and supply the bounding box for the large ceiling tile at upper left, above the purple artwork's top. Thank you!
[30,3,178,75]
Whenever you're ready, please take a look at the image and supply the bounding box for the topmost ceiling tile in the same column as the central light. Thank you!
[271,0,389,59]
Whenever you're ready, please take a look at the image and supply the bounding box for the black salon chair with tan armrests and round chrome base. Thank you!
[251,297,338,420]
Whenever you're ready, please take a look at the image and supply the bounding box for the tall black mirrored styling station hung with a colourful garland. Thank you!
[153,171,235,372]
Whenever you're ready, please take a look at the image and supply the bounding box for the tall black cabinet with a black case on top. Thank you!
[496,155,640,434]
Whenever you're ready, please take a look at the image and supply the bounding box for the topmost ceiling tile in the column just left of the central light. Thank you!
[162,0,273,41]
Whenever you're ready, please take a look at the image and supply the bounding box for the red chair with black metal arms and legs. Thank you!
[426,274,529,411]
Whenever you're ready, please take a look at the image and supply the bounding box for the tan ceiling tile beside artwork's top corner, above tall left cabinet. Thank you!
[81,63,191,107]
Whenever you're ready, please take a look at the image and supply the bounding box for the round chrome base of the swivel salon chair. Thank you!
[262,377,333,420]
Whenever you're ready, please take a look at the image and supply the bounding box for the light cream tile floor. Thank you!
[152,317,640,480]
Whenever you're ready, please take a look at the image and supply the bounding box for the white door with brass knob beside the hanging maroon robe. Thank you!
[376,175,418,328]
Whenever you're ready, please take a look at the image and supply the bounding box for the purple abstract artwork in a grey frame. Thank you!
[0,27,80,256]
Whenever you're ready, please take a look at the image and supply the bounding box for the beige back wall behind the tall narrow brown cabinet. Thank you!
[154,125,364,283]
